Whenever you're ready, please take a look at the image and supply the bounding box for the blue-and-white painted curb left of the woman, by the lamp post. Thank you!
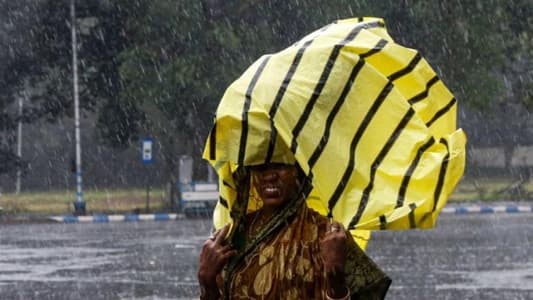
[48,213,185,223]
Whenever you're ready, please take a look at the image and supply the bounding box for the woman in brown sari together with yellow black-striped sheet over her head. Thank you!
[198,18,466,299]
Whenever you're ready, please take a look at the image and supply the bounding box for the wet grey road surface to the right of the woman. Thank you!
[368,214,533,300]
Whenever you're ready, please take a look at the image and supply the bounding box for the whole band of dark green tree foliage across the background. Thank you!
[0,0,533,178]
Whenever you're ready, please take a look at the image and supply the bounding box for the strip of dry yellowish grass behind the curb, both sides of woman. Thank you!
[0,178,533,214]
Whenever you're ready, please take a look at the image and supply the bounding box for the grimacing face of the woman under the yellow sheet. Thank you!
[251,163,299,209]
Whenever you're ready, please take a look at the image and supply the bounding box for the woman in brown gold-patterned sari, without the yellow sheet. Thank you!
[198,163,390,299]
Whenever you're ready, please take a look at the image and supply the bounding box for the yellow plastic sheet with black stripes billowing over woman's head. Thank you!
[204,18,466,234]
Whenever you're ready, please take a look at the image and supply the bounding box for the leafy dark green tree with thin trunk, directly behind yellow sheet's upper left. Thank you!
[111,0,356,204]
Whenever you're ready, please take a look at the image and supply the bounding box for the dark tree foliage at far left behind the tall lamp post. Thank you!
[0,0,143,175]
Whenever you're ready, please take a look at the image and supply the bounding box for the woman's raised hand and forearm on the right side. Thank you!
[320,222,349,298]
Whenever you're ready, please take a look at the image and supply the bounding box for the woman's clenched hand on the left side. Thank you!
[198,224,237,290]
